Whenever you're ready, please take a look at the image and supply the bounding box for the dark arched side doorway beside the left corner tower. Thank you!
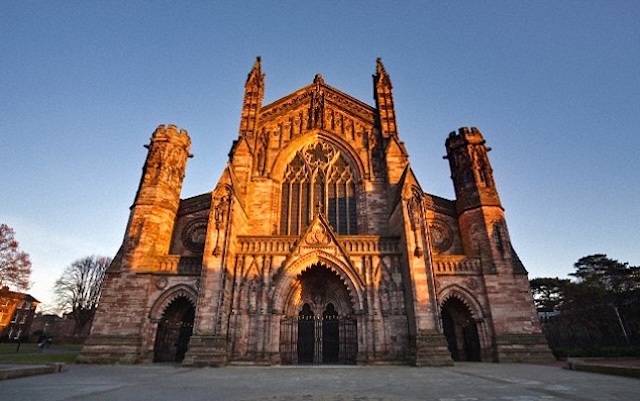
[153,297,195,362]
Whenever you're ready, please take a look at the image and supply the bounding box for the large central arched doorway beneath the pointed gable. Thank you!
[280,265,358,365]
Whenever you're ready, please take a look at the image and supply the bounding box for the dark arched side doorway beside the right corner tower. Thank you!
[441,298,480,361]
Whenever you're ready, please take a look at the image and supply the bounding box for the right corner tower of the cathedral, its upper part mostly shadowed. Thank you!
[445,127,551,362]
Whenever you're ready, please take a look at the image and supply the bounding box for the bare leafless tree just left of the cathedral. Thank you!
[54,255,111,335]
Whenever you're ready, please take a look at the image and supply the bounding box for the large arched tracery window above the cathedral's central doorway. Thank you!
[280,143,358,235]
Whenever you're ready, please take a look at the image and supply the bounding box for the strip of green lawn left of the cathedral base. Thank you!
[0,343,82,365]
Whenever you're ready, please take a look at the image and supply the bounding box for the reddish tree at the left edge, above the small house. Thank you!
[0,223,31,291]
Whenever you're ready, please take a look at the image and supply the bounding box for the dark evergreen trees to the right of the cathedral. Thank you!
[530,254,640,354]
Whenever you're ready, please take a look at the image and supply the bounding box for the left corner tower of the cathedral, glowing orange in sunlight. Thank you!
[78,125,191,363]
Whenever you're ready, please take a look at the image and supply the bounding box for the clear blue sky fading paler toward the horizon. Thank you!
[0,0,640,305]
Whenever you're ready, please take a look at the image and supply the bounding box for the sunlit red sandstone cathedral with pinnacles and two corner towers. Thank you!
[80,58,551,366]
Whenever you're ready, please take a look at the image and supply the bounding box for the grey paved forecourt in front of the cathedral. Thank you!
[0,363,640,401]
